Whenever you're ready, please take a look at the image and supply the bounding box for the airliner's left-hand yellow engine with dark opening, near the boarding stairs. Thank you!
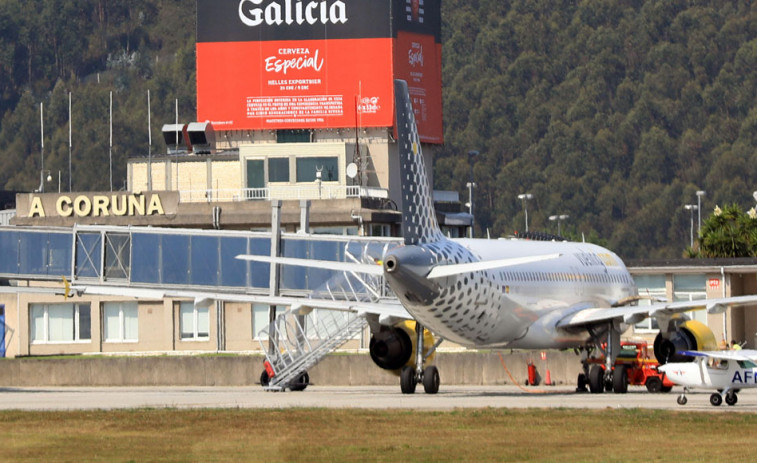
[370,321,434,375]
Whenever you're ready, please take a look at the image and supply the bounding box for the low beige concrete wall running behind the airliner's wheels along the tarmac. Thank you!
[0,351,580,388]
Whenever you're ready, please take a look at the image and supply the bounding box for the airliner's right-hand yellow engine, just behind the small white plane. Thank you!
[654,320,718,365]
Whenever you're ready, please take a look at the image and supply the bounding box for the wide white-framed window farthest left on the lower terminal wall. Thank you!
[30,304,92,343]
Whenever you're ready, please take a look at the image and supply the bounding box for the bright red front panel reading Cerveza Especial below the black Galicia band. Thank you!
[197,39,393,130]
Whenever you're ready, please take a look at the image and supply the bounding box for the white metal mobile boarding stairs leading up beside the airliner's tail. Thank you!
[258,243,390,391]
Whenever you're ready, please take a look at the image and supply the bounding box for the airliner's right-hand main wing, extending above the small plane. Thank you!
[557,295,757,328]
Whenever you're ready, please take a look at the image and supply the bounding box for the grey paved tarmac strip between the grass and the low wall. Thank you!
[0,386,757,412]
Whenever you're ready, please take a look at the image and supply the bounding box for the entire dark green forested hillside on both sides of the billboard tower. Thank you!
[0,0,757,258]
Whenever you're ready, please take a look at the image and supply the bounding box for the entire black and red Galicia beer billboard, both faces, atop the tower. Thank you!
[197,0,441,143]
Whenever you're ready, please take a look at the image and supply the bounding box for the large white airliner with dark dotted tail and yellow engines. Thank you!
[237,80,757,394]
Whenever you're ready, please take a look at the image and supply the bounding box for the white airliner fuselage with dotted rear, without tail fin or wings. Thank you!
[386,239,636,348]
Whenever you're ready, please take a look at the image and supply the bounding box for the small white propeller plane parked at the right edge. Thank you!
[658,349,757,407]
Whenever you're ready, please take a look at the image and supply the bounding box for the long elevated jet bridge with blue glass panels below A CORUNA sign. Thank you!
[0,226,400,299]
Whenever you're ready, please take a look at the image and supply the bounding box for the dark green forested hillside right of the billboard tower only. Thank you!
[436,0,757,258]
